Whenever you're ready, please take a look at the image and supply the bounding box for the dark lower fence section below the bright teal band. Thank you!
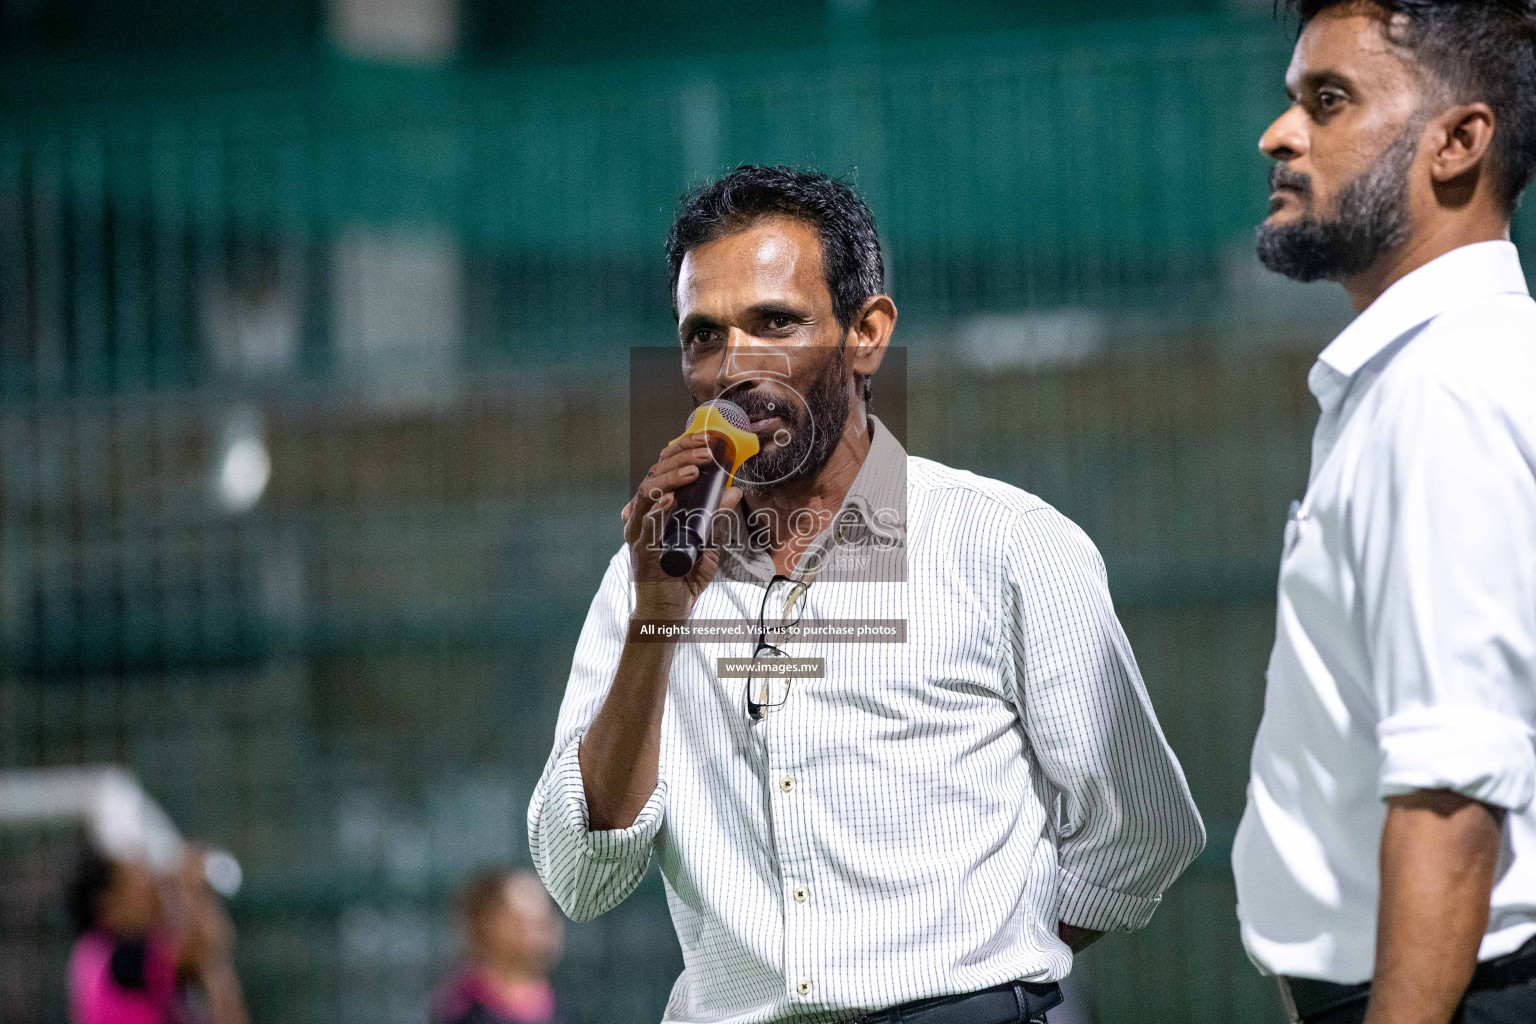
[0,350,1312,1024]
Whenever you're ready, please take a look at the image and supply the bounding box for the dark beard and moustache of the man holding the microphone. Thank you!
[725,345,848,494]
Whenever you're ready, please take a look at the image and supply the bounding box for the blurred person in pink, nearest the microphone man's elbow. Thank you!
[432,870,574,1024]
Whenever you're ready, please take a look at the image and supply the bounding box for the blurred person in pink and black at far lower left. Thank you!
[69,852,247,1024]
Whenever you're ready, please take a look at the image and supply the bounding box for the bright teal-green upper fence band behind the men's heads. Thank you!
[0,21,1287,395]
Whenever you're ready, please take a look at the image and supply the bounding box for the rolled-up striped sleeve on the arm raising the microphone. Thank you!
[528,550,667,921]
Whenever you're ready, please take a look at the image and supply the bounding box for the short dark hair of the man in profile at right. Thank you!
[1289,0,1536,212]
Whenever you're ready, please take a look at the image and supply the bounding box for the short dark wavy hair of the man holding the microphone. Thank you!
[667,164,885,330]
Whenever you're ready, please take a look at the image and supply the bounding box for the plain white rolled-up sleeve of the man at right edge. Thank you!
[1349,366,1536,812]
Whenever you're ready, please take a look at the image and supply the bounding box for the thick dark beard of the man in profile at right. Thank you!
[1256,123,1421,281]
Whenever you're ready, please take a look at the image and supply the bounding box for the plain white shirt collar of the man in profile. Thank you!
[1312,241,1530,396]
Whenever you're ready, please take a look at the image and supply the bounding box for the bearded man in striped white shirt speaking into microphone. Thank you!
[528,167,1204,1024]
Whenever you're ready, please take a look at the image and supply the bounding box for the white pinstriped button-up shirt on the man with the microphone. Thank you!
[528,425,1204,1022]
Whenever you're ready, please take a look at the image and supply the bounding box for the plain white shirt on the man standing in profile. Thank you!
[1232,241,1536,984]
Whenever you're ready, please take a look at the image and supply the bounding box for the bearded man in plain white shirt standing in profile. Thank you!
[1232,0,1536,1024]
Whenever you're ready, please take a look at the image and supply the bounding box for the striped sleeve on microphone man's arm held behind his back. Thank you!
[1006,508,1206,930]
